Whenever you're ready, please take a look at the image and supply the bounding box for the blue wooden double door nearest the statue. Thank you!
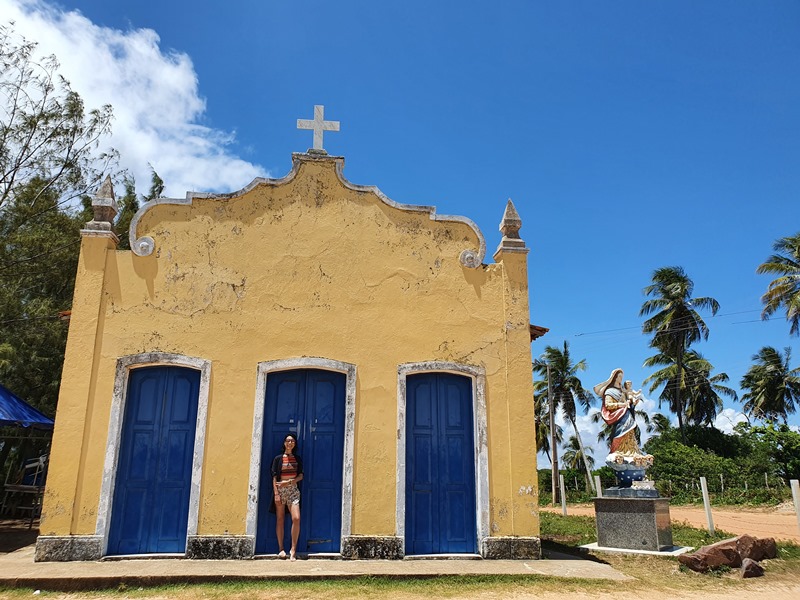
[405,373,477,555]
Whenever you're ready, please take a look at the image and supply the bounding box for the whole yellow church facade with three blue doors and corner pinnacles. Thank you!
[36,150,540,561]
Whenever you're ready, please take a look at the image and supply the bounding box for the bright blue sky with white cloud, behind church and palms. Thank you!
[0,0,800,458]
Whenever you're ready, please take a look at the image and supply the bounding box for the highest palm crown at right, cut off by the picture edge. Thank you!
[756,232,800,336]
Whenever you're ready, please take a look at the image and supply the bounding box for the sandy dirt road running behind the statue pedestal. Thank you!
[542,503,800,544]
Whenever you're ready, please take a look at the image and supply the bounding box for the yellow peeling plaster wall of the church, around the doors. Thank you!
[37,155,539,536]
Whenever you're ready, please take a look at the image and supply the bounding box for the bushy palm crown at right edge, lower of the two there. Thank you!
[740,346,800,423]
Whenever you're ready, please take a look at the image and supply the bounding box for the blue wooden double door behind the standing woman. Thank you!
[256,369,346,554]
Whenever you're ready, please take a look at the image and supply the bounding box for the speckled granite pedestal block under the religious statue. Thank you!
[594,488,672,552]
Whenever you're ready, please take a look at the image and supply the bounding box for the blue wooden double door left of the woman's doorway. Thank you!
[108,367,200,554]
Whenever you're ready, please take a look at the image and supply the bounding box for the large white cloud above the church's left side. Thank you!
[0,0,266,197]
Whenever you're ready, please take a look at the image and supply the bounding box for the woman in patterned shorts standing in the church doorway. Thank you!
[271,433,303,560]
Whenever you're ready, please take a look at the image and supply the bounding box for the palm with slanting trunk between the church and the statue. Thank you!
[533,341,594,487]
